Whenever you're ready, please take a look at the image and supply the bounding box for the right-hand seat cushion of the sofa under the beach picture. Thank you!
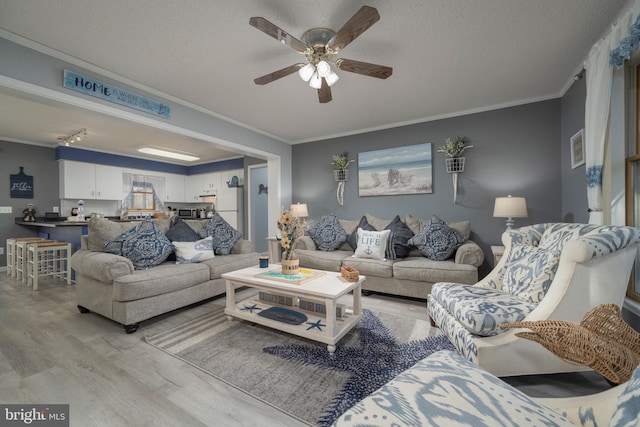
[393,256,478,284]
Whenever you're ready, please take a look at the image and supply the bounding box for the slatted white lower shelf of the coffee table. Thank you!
[224,298,362,353]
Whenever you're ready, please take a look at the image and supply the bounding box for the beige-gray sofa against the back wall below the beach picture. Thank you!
[295,214,484,299]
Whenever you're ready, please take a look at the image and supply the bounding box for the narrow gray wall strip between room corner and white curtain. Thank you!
[559,78,589,222]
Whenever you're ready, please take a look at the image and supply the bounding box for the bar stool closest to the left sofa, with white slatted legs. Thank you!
[27,241,71,291]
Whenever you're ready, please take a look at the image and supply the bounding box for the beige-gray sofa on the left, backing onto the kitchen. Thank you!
[71,218,258,333]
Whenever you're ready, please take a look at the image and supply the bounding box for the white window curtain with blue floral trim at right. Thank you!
[584,0,640,224]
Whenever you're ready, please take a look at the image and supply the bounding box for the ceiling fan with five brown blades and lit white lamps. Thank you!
[249,6,393,103]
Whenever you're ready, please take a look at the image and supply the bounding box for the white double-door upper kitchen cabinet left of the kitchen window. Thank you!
[59,160,123,200]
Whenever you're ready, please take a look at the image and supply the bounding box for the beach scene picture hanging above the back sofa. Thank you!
[358,143,433,197]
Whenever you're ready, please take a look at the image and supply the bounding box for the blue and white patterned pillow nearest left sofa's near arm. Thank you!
[103,218,174,270]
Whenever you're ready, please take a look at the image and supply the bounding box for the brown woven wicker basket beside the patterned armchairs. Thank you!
[502,304,640,384]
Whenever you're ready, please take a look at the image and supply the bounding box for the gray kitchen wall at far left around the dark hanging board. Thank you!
[0,141,60,267]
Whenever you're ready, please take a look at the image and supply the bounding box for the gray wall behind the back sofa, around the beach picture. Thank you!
[292,99,563,275]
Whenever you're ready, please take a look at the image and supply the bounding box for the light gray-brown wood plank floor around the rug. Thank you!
[0,271,608,427]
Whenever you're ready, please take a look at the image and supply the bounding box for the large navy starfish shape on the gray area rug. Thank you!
[263,309,455,426]
